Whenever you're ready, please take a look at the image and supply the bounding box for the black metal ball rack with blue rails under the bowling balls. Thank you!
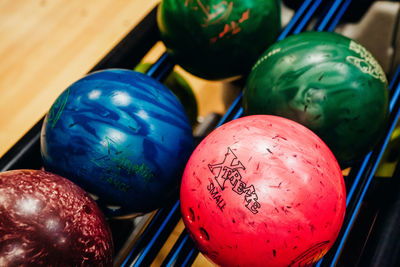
[0,0,400,266]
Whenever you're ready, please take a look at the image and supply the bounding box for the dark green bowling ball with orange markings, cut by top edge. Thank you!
[157,0,281,80]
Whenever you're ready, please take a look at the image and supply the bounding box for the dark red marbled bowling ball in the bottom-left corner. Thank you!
[0,170,113,266]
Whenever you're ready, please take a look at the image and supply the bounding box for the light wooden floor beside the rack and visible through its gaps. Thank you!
[0,0,229,266]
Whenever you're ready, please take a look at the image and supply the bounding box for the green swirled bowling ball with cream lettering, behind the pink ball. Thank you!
[243,32,389,166]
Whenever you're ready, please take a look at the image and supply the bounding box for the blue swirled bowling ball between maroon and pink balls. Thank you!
[41,69,193,217]
